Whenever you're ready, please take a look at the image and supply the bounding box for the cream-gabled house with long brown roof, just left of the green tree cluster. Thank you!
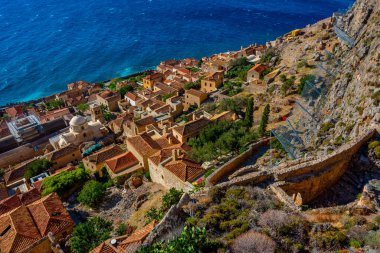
[173,117,211,143]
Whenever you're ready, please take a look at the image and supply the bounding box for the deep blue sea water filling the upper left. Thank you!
[0,0,353,105]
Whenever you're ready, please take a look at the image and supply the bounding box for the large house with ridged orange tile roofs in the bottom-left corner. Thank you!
[0,193,75,253]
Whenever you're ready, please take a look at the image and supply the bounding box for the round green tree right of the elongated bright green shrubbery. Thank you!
[77,180,105,207]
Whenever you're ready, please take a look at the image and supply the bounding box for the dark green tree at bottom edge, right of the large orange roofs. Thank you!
[70,217,112,253]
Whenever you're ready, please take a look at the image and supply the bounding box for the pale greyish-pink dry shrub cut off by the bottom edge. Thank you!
[231,230,276,253]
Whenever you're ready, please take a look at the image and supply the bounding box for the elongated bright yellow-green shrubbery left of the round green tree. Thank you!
[42,168,88,196]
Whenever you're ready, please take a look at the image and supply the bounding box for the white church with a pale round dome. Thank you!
[49,116,107,149]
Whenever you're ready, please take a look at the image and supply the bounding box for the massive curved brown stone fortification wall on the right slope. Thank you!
[214,130,376,205]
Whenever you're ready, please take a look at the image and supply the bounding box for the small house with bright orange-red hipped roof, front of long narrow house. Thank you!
[106,152,143,179]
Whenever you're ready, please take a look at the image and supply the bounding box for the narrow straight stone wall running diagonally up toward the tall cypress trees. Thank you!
[206,138,270,187]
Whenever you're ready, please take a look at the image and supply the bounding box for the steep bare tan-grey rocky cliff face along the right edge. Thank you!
[325,0,380,139]
